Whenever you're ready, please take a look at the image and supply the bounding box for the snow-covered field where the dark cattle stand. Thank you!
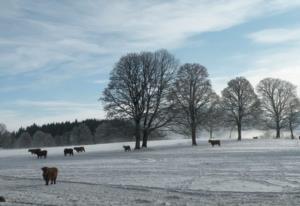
[0,139,300,206]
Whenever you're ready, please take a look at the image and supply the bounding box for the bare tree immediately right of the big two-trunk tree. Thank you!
[170,64,213,145]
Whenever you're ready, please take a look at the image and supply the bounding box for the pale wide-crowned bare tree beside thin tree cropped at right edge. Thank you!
[257,78,297,138]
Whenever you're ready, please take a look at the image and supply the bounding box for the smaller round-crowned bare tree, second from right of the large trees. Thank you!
[222,77,260,140]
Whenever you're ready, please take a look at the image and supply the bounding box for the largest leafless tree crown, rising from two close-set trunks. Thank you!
[101,50,177,149]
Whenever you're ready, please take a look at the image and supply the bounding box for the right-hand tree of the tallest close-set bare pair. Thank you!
[141,50,177,147]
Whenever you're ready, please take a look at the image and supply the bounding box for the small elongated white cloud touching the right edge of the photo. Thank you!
[249,27,300,44]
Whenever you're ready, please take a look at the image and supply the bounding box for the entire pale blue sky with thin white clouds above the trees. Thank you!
[0,0,300,130]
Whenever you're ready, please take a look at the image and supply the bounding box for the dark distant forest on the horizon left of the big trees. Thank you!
[0,119,161,148]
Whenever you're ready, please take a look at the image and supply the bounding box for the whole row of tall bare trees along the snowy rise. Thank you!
[100,50,300,149]
